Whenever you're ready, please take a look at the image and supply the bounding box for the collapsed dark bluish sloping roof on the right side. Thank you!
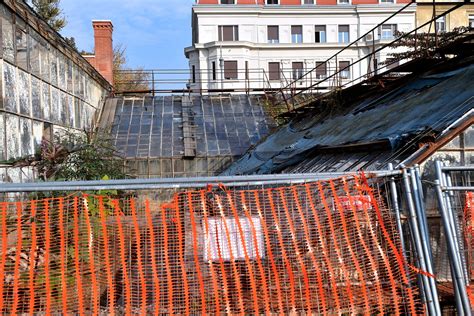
[224,58,474,175]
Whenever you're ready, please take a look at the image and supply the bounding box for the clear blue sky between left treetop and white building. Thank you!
[61,0,194,69]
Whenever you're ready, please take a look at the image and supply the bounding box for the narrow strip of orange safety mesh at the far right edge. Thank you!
[463,192,474,306]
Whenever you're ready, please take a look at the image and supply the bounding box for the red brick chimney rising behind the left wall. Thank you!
[88,21,114,85]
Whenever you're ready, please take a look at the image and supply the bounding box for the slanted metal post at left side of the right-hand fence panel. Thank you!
[435,180,471,315]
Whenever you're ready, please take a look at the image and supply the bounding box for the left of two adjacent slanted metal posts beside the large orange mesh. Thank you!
[403,169,436,315]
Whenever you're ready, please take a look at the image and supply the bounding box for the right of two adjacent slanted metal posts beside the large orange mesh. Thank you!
[410,168,441,315]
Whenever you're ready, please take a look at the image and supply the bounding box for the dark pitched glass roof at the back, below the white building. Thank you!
[112,95,274,158]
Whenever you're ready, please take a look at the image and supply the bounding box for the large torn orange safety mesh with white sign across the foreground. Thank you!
[0,177,424,315]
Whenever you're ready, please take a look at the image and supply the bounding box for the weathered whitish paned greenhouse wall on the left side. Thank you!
[0,1,110,182]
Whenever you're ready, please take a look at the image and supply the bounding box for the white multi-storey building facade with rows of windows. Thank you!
[185,0,416,92]
